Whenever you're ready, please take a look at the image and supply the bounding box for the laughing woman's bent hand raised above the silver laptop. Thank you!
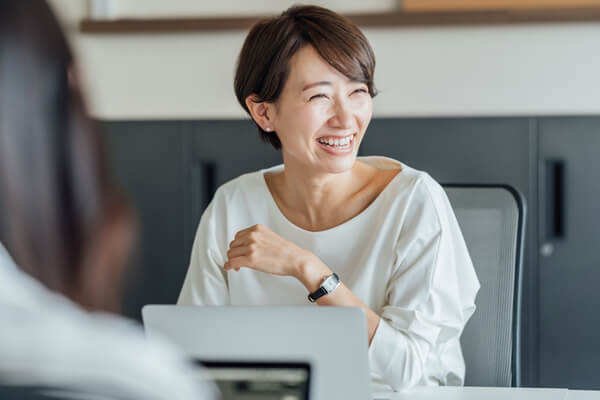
[223,225,312,277]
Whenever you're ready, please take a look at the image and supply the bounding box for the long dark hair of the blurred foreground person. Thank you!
[0,0,119,293]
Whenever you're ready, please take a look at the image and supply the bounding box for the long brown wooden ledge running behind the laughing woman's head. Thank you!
[80,7,600,33]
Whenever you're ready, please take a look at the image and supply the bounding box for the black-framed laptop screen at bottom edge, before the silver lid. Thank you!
[195,360,310,400]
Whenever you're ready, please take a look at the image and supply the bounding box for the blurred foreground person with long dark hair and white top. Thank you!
[0,0,213,399]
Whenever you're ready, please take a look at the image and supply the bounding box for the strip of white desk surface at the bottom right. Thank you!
[373,387,600,400]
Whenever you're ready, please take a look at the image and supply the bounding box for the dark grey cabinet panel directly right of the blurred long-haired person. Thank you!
[102,122,187,319]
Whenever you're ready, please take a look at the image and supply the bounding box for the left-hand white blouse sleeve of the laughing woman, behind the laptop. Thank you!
[177,191,230,305]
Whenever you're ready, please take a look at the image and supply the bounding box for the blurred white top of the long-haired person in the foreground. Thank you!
[0,244,217,400]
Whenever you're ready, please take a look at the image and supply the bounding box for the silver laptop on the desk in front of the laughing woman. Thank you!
[142,305,372,400]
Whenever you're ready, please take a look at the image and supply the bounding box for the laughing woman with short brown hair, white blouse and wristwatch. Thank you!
[179,6,479,390]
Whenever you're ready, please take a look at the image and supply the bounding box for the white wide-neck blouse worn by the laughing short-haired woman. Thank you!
[178,157,479,391]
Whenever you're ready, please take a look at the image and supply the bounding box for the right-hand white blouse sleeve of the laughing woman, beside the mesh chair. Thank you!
[369,176,479,390]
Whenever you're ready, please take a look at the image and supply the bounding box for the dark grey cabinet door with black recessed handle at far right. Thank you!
[538,117,600,389]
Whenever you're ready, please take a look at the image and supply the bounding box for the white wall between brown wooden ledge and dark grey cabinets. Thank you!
[48,0,600,119]
